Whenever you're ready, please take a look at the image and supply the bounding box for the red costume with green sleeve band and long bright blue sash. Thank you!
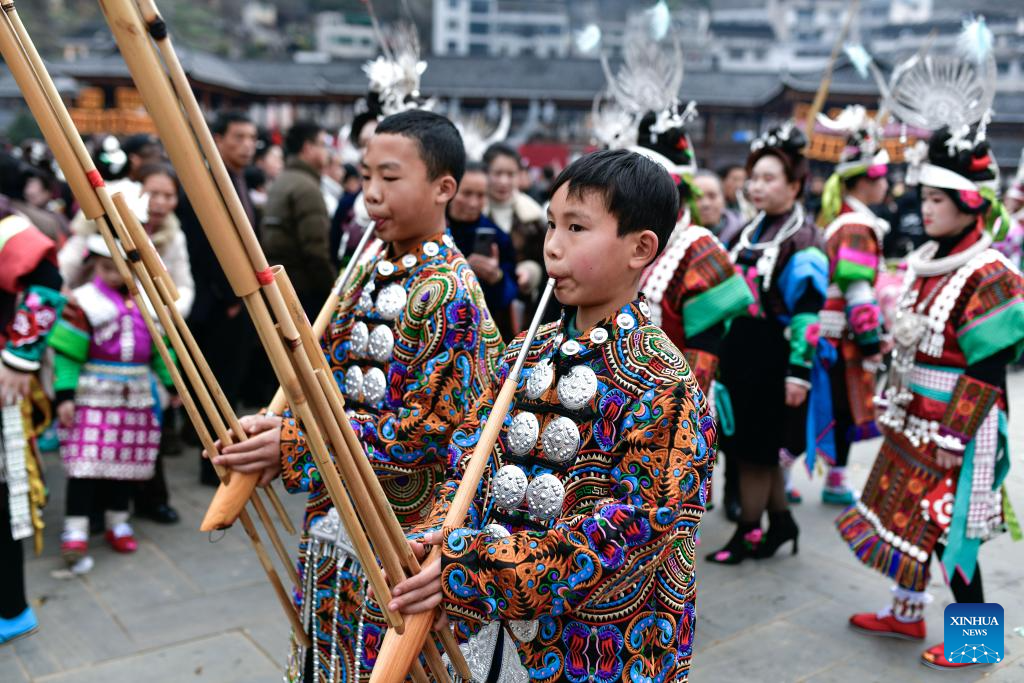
[808,198,889,467]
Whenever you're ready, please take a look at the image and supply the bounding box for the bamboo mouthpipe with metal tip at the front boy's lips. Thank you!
[370,280,555,683]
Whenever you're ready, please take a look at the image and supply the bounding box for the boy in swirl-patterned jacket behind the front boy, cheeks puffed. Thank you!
[215,111,502,681]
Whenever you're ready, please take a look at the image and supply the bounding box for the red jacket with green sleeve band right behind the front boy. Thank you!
[640,224,754,395]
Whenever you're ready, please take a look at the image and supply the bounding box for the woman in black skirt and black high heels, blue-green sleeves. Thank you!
[708,124,828,564]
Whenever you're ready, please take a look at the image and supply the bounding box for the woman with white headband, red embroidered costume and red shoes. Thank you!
[837,121,1024,669]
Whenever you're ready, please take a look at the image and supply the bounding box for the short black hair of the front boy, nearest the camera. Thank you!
[551,150,679,254]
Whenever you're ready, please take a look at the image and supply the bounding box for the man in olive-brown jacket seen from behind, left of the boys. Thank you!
[261,121,336,319]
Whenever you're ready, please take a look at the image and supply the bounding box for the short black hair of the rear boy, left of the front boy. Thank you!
[374,110,466,182]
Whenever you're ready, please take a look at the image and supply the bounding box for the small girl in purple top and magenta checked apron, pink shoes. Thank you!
[49,234,173,570]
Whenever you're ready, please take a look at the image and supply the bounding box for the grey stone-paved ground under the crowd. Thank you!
[0,374,1024,683]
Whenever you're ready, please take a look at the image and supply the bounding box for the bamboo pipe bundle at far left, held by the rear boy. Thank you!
[0,2,308,642]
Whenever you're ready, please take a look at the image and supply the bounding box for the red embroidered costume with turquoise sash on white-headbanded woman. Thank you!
[837,227,1024,590]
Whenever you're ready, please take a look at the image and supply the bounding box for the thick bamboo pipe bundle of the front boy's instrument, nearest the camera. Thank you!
[100,0,468,677]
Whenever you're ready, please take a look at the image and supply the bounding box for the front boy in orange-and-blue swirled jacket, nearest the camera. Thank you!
[392,151,716,682]
